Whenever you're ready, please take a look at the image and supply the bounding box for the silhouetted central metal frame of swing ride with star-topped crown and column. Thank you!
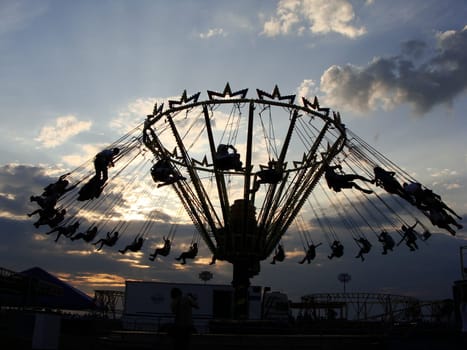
[143,84,346,319]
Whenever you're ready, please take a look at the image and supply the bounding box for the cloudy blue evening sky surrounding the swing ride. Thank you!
[0,0,467,300]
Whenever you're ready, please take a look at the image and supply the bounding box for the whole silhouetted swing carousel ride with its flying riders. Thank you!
[27,83,462,319]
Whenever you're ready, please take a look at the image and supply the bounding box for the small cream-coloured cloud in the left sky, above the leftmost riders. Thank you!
[36,115,92,148]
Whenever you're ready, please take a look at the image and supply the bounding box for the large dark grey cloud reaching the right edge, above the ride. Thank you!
[320,26,467,115]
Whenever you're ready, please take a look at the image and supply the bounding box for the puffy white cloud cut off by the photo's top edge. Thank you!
[262,0,366,39]
